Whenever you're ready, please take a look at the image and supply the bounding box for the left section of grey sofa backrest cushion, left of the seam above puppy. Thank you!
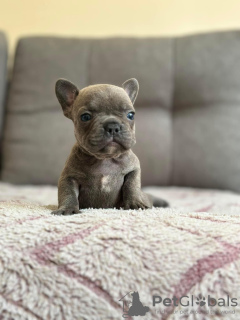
[3,38,90,184]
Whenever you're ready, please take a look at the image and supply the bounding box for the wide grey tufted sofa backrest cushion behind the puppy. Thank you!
[2,31,240,191]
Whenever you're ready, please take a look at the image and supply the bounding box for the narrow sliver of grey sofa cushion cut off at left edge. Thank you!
[0,32,8,159]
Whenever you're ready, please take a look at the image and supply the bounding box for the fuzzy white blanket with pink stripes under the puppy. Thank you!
[0,183,240,320]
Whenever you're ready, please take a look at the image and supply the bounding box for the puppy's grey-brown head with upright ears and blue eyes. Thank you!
[56,79,139,159]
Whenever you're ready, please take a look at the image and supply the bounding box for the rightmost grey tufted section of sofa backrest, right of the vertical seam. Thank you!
[172,31,240,192]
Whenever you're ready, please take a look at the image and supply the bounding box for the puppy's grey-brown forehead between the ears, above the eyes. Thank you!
[75,84,133,112]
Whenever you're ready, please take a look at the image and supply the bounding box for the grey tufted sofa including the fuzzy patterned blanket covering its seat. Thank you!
[0,31,240,319]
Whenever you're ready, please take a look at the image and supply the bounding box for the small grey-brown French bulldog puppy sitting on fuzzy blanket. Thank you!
[52,79,168,215]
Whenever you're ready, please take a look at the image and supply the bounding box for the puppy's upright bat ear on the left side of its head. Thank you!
[55,79,79,119]
